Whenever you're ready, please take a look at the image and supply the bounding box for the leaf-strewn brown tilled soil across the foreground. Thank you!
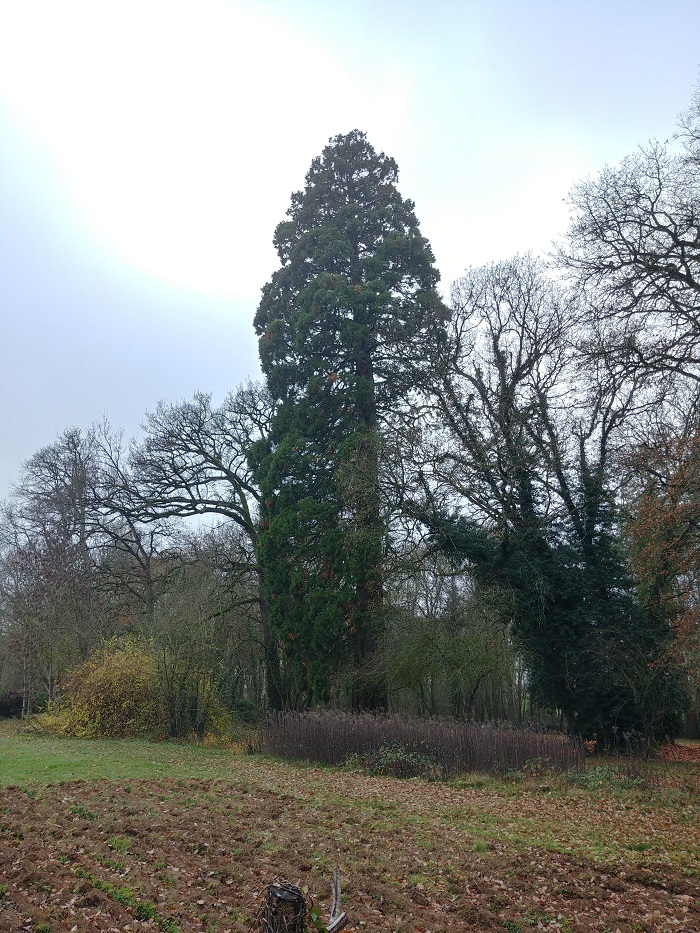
[0,759,700,933]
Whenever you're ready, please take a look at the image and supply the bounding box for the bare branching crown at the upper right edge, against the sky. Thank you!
[558,84,700,381]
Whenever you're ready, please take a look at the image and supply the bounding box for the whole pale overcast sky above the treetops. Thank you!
[0,0,700,499]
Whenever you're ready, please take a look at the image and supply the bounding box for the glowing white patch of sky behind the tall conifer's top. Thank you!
[0,0,624,308]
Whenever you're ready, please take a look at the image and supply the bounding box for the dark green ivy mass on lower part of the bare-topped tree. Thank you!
[429,506,684,743]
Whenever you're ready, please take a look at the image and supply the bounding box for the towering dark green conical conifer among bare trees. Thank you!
[254,130,445,706]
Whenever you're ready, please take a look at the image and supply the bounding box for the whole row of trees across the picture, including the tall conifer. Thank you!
[0,87,700,740]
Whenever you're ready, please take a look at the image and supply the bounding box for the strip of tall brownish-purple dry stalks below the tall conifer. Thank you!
[253,711,583,780]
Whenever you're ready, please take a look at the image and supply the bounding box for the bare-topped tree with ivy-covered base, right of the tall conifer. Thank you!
[422,258,682,741]
